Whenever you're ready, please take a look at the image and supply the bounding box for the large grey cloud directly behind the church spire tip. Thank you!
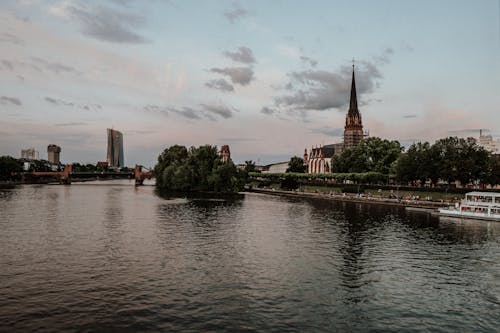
[274,61,382,111]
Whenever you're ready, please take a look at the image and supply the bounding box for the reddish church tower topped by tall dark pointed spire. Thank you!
[344,65,363,149]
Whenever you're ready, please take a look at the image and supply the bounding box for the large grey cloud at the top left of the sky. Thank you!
[49,2,147,43]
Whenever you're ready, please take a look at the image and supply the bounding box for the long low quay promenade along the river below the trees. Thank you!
[248,188,450,211]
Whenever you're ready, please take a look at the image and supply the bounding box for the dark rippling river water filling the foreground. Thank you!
[0,181,500,332]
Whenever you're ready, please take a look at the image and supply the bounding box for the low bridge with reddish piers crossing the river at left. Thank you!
[25,164,154,186]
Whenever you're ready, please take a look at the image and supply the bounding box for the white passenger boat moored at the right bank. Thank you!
[437,192,500,221]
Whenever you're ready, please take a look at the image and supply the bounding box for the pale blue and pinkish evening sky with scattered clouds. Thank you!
[0,0,500,166]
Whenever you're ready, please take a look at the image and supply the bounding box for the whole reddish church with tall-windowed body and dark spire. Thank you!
[304,65,364,173]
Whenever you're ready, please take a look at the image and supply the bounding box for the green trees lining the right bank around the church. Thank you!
[287,137,500,185]
